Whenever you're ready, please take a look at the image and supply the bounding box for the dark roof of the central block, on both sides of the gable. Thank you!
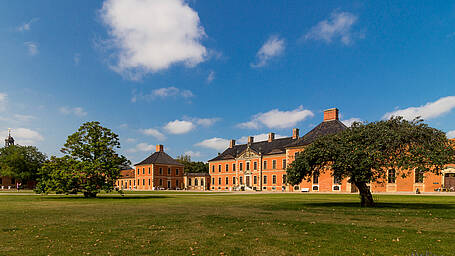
[209,137,296,161]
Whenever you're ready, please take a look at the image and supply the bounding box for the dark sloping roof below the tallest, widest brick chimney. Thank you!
[288,120,348,147]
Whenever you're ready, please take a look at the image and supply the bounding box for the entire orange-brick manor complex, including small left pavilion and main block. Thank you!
[116,108,455,192]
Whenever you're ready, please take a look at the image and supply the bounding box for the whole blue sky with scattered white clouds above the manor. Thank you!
[0,0,455,163]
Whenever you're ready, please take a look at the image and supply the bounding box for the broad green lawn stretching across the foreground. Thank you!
[0,192,455,255]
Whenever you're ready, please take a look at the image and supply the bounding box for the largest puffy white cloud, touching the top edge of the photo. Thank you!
[101,0,207,79]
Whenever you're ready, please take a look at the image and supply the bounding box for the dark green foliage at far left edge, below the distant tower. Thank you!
[0,145,47,182]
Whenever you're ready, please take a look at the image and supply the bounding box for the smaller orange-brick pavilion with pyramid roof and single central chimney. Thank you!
[116,145,184,190]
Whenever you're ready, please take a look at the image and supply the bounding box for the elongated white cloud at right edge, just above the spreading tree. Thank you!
[383,96,455,120]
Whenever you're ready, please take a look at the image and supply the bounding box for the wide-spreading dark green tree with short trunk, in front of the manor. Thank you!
[287,117,455,206]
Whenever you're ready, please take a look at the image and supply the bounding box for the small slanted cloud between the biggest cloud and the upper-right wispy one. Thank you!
[251,35,285,68]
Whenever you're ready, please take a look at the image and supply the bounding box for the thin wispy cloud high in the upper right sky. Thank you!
[304,11,361,45]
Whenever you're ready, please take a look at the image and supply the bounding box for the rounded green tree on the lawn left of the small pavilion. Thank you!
[37,122,129,197]
